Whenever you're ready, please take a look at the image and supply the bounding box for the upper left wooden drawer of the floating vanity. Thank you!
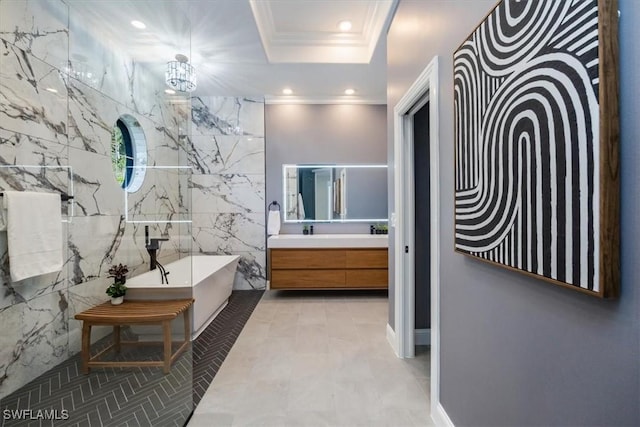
[271,249,346,269]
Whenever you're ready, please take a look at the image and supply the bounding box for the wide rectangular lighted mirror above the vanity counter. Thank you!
[282,164,387,222]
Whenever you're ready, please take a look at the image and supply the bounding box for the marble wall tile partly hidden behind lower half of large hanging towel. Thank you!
[0,223,69,310]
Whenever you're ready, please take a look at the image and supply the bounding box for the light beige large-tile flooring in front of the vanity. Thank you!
[188,291,431,427]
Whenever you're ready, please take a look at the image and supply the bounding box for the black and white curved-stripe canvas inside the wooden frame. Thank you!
[454,0,600,293]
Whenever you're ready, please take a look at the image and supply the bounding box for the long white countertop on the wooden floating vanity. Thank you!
[267,234,389,248]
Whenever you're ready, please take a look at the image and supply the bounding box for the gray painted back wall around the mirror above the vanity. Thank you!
[265,104,387,234]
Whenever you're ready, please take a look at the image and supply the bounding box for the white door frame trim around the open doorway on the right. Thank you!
[393,56,440,418]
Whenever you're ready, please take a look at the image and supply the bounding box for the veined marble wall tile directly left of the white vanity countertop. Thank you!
[192,213,266,254]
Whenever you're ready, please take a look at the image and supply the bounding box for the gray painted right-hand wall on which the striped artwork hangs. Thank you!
[387,0,640,426]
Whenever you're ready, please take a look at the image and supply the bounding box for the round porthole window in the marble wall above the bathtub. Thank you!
[111,114,147,193]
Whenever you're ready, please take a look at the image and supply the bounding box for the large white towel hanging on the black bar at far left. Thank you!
[3,191,62,282]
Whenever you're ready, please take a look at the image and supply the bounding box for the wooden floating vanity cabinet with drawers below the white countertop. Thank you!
[269,248,388,289]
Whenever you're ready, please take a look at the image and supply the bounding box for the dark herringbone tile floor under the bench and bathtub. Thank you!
[0,291,263,427]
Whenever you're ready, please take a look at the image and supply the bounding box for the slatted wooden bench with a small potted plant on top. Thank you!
[75,298,194,374]
